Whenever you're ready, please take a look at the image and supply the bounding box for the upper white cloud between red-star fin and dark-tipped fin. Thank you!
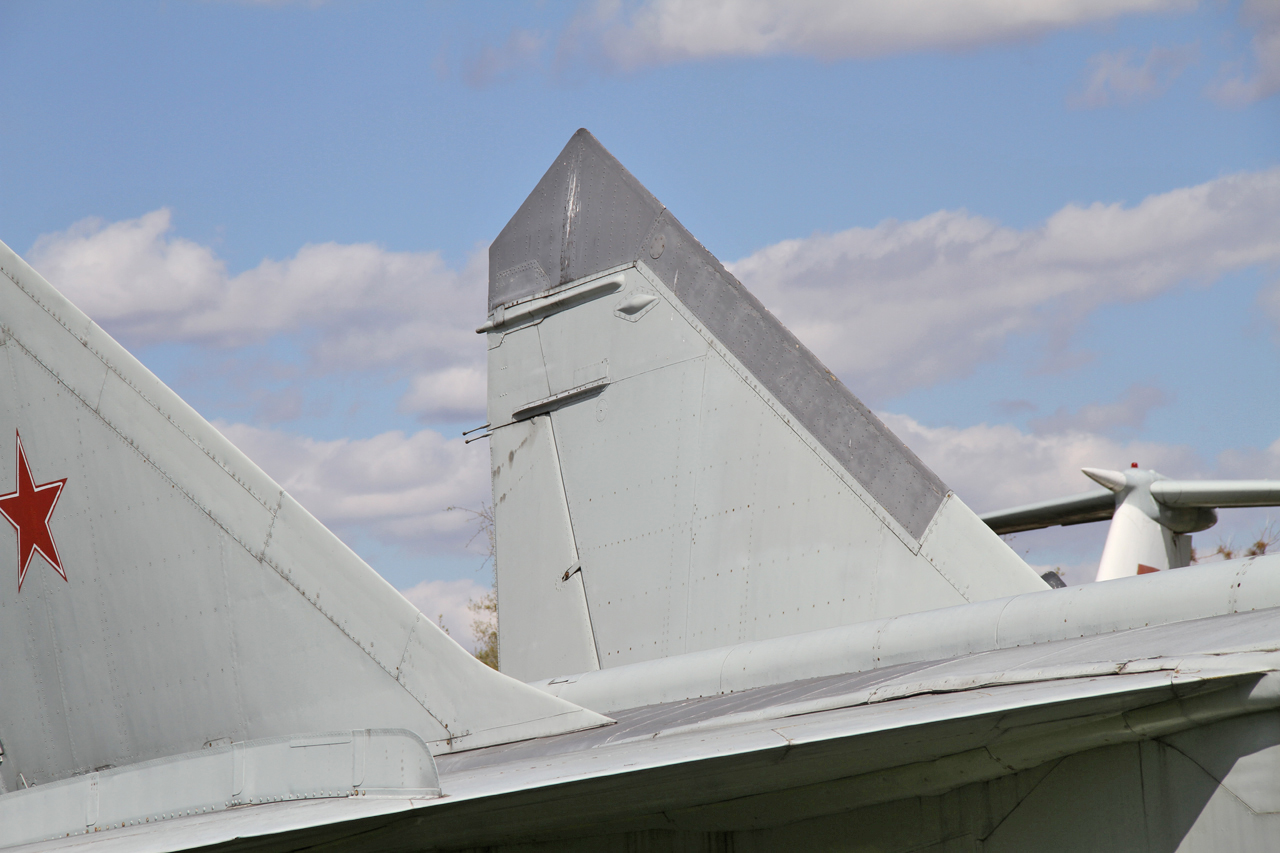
[29,210,486,419]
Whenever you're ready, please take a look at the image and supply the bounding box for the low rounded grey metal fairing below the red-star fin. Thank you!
[0,729,440,847]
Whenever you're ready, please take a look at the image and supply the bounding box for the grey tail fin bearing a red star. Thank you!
[0,235,603,792]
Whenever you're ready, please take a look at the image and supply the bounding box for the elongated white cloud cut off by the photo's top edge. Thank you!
[562,0,1196,68]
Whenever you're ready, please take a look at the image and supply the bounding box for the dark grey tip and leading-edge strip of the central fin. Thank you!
[489,128,947,540]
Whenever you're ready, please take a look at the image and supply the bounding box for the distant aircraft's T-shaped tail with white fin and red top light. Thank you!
[982,462,1280,583]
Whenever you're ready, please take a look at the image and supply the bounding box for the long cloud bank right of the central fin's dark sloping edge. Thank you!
[730,169,1280,398]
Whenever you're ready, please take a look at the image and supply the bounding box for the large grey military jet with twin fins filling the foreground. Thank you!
[0,131,1280,853]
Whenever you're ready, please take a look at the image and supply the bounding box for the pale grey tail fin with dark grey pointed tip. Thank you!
[480,131,1046,680]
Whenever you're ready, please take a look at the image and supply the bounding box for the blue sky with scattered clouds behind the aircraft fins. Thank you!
[0,0,1280,642]
